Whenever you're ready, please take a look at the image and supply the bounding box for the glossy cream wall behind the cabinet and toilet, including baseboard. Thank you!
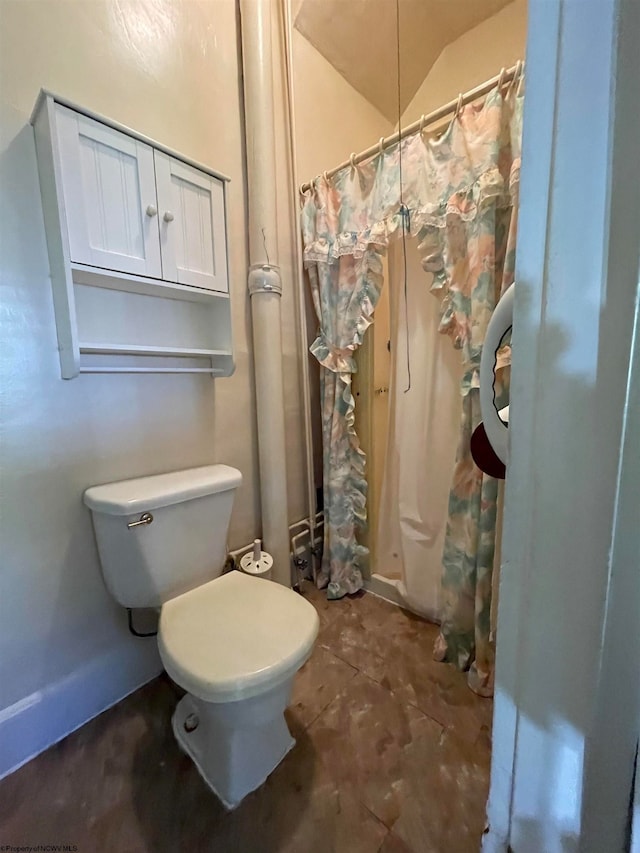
[0,0,306,775]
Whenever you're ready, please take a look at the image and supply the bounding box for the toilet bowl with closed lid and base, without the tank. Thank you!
[158,571,318,808]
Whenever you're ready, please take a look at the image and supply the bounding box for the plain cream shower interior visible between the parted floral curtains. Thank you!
[364,240,461,621]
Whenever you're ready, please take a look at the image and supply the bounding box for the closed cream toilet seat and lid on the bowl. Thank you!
[158,571,319,702]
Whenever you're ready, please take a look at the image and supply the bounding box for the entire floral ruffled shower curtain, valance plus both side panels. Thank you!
[302,89,522,694]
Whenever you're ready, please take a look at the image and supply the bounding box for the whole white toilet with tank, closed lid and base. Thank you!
[84,465,318,808]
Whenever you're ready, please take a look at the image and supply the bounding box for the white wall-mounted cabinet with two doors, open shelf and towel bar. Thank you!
[31,91,233,379]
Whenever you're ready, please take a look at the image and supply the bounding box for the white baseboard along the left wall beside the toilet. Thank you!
[0,638,162,779]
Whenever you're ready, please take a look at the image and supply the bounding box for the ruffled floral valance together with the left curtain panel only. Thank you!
[302,89,522,597]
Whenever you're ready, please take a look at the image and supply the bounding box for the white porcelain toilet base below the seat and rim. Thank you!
[172,678,295,809]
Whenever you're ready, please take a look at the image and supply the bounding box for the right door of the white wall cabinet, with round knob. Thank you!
[155,150,229,293]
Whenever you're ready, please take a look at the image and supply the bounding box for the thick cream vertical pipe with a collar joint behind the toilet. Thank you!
[240,0,291,586]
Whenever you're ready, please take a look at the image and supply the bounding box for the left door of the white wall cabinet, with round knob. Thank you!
[56,104,162,278]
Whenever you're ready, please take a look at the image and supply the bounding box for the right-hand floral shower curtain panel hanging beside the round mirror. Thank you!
[421,91,523,696]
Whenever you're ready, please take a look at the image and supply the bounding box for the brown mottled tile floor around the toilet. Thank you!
[0,584,492,853]
